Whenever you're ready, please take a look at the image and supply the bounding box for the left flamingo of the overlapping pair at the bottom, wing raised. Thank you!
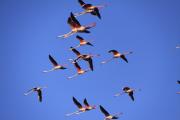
[66,97,86,116]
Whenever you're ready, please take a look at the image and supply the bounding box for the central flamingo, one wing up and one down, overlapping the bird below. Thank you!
[70,47,100,71]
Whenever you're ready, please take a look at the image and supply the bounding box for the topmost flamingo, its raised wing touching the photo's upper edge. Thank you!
[75,0,104,19]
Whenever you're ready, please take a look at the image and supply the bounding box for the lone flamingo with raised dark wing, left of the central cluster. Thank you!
[43,55,67,73]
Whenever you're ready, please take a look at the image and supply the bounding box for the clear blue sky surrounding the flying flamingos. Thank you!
[0,0,180,120]
